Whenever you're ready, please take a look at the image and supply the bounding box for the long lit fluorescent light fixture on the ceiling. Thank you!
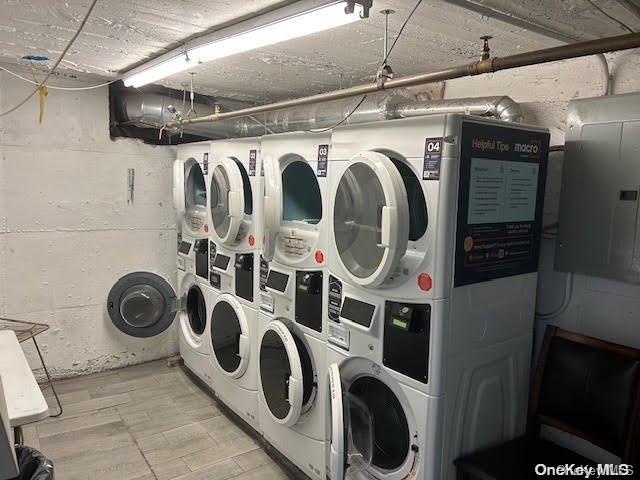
[124,1,364,88]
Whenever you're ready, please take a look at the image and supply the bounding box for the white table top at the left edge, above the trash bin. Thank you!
[0,330,49,427]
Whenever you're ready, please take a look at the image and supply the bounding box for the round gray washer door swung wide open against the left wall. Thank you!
[107,272,177,338]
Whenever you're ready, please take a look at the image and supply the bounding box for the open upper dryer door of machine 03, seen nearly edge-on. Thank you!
[262,156,282,261]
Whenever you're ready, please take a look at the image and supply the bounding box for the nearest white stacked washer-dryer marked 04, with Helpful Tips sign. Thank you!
[327,115,549,480]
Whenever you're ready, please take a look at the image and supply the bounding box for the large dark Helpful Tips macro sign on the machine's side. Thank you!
[454,121,549,287]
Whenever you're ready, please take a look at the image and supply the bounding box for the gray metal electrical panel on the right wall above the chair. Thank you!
[555,93,640,283]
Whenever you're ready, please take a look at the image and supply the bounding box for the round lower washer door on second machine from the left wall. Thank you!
[211,294,251,378]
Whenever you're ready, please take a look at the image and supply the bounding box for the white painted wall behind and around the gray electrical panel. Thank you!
[445,50,640,347]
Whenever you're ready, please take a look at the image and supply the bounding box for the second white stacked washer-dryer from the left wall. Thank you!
[208,138,262,430]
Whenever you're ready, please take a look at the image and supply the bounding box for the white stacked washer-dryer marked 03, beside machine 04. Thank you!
[258,133,330,480]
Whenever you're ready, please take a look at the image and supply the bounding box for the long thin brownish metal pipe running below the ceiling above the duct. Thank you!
[162,33,640,128]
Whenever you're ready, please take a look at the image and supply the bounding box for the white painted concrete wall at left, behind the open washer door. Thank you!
[0,71,177,377]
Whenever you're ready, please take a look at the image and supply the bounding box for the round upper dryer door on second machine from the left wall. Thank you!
[209,158,245,244]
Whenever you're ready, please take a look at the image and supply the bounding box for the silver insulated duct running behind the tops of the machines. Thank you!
[117,90,523,139]
